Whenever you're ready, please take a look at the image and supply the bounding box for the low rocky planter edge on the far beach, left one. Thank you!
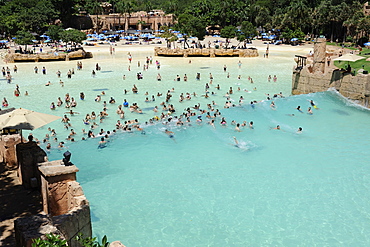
[5,49,93,63]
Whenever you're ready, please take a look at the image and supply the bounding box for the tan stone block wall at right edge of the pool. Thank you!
[292,66,370,108]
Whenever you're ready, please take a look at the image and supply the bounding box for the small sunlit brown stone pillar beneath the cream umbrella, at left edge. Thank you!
[0,134,21,168]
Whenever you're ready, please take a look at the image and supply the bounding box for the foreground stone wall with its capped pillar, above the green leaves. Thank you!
[15,160,92,247]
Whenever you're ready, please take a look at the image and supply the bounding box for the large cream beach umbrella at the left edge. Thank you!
[0,108,61,141]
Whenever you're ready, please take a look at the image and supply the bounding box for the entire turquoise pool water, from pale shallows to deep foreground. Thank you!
[1,45,370,247]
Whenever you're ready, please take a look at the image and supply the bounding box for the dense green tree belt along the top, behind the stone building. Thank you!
[0,0,370,40]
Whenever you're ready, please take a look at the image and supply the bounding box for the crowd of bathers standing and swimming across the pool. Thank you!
[2,49,315,150]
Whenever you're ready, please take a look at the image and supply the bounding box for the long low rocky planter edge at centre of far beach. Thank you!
[154,47,258,57]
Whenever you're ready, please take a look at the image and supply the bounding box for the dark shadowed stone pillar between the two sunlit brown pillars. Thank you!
[16,142,47,189]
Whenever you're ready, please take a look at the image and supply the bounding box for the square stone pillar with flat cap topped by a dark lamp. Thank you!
[39,160,78,216]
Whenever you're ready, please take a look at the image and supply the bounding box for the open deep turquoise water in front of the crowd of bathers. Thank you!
[49,92,370,246]
